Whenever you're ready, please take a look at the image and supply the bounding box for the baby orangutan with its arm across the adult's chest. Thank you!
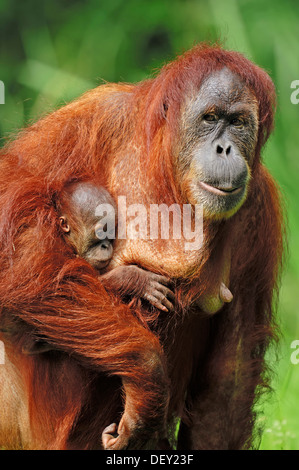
[59,182,174,311]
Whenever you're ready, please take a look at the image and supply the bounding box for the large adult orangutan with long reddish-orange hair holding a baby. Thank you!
[0,44,283,449]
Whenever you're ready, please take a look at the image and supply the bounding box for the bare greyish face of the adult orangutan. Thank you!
[179,68,258,219]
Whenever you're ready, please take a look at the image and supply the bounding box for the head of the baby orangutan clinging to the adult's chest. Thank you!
[59,183,115,270]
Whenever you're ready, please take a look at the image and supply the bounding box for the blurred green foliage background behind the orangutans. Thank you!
[0,0,299,449]
